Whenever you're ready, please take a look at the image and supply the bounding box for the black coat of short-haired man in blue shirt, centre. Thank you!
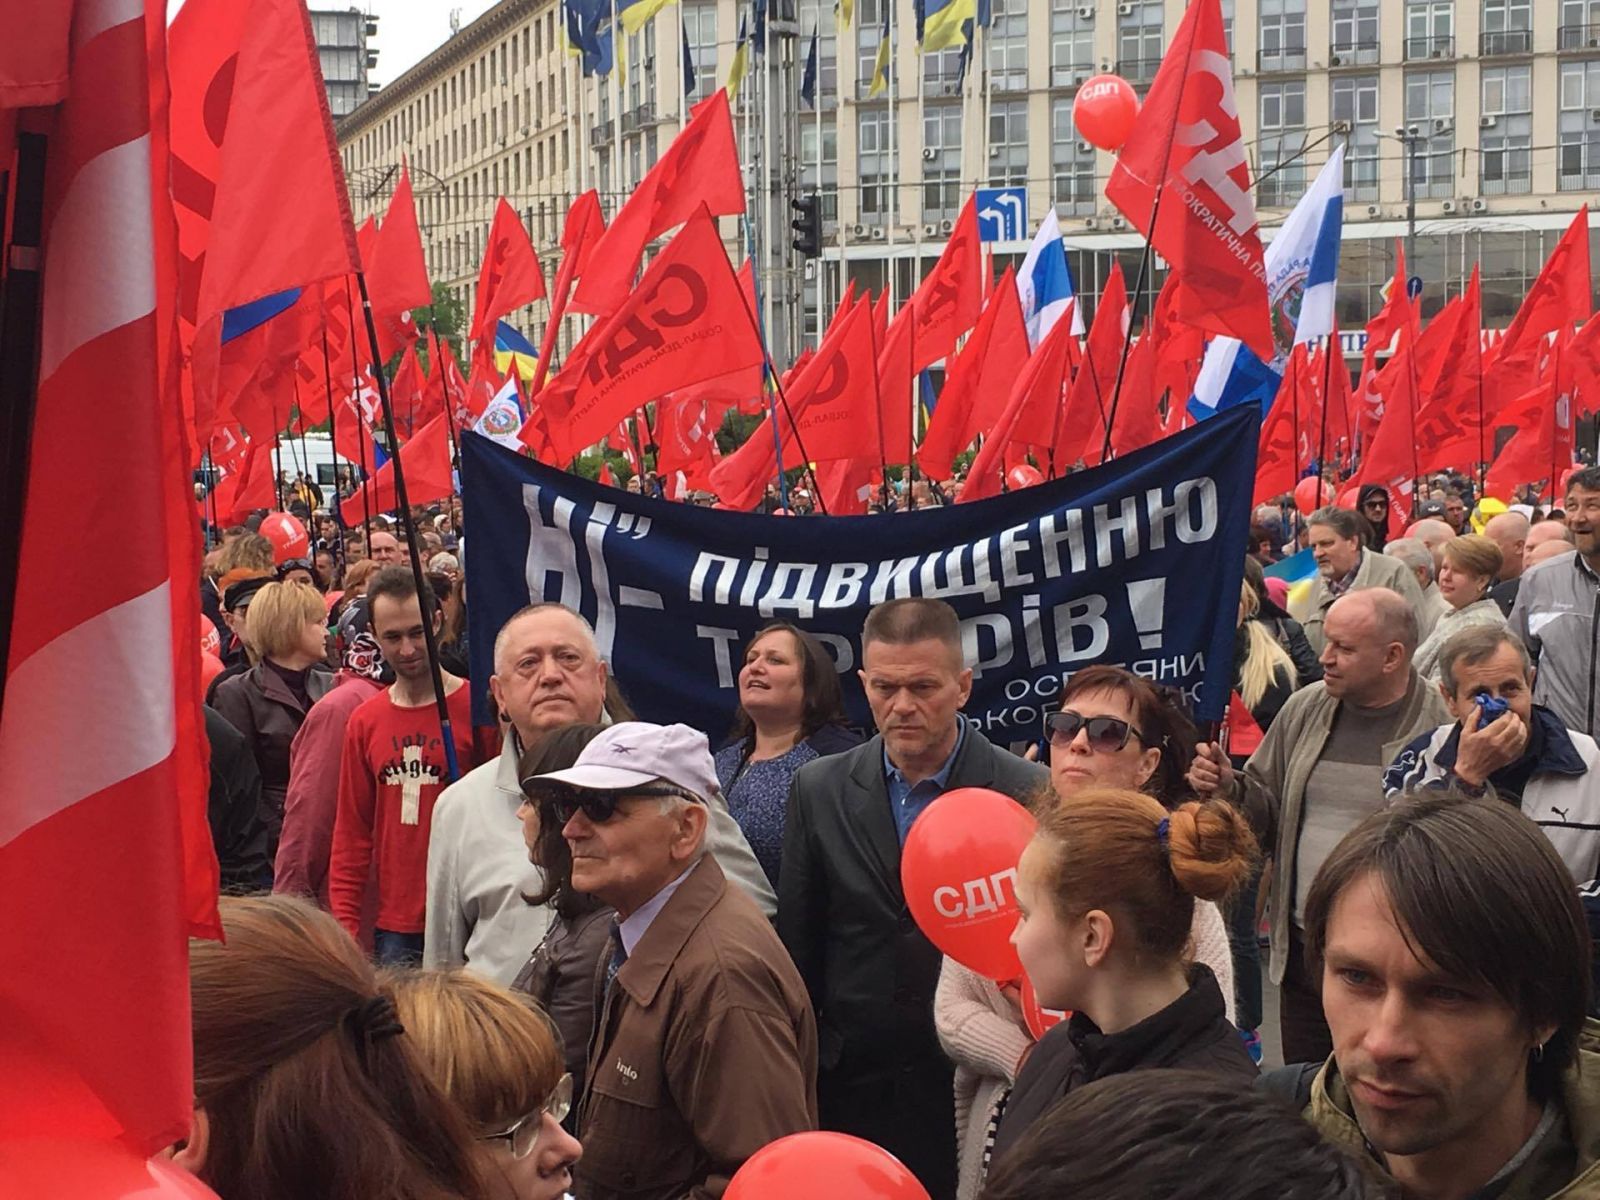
[778,728,1050,1200]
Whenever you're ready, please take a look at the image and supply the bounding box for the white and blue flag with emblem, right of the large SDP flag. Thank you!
[1189,146,1344,421]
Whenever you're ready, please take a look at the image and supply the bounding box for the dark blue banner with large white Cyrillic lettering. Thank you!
[461,405,1259,742]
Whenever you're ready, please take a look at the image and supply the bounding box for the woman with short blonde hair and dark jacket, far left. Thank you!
[211,582,333,858]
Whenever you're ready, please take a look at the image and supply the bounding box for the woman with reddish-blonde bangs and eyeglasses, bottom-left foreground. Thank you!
[389,971,582,1200]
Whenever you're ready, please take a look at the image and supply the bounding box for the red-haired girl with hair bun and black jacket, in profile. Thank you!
[994,787,1256,1162]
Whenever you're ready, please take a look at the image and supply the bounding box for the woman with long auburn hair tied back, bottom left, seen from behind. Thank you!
[173,896,490,1200]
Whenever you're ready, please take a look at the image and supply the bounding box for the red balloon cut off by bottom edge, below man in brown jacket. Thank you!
[723,1139,938,1200]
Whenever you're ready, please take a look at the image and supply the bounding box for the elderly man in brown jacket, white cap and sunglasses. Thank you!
[525,722,816,1200]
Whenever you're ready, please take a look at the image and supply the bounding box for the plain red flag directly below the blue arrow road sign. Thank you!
[917,267,1027,480]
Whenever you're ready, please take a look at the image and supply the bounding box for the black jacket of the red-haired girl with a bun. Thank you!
[994,963,1256,1163]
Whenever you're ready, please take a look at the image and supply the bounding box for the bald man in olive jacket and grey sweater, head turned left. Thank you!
[1189,587,1450,1062]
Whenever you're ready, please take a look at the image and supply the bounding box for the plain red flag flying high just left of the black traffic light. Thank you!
[573,90,749,323]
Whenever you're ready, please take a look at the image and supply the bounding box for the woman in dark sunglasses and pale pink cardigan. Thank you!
[933,666,1234,1200]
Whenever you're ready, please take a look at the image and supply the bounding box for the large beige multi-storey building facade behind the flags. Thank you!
[339,0,1600,371]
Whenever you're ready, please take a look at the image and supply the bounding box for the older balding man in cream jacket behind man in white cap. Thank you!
[422,603,778,984]
